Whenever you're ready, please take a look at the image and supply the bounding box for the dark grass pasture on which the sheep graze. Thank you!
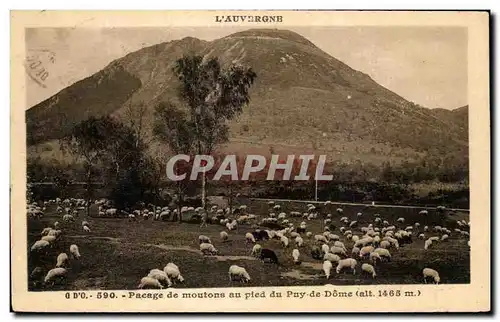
[27,201,470,291]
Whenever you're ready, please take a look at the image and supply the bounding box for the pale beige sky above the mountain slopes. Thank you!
[25,26,468,109]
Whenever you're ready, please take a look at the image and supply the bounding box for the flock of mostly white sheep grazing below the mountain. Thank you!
[27,198,470,289]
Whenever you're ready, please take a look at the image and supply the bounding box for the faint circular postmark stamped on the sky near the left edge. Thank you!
[24,49,56,88]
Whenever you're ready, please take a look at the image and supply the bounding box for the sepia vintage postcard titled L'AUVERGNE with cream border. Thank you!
[10,11,491,312]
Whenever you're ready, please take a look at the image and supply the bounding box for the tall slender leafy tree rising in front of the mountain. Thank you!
[169,56,257,222]
